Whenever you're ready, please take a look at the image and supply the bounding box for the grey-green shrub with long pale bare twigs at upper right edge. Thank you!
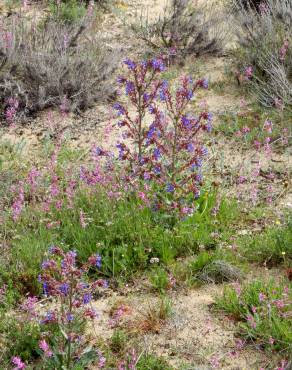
[233,0,292,106]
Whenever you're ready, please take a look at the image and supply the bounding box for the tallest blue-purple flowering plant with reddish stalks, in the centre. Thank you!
[114,59,212,214]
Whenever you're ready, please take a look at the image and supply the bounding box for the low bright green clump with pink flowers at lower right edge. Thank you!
[216,280,292,354]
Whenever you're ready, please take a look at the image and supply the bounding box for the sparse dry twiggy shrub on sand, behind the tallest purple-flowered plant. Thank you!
[132,0,227,59]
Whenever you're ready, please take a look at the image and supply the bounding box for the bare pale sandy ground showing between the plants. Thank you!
[2,0,291,370]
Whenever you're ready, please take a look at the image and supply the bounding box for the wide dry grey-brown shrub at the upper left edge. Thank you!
[0,18,115,121]
